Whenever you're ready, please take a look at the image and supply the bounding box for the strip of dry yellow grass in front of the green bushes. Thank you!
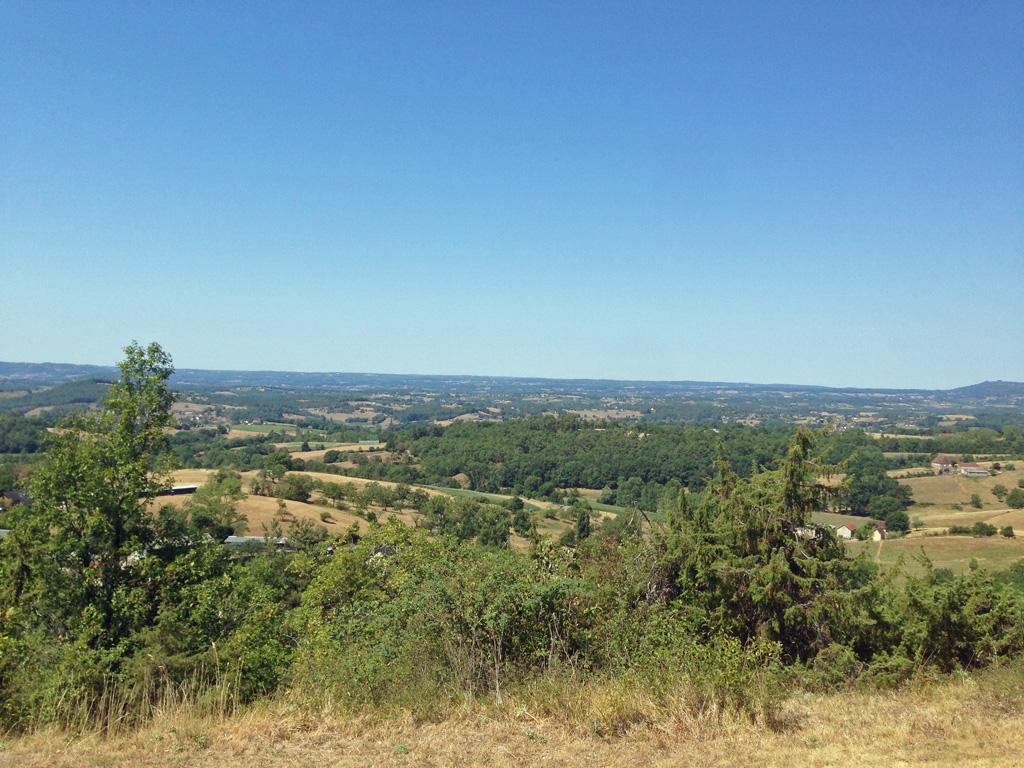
[0,675,1024,768]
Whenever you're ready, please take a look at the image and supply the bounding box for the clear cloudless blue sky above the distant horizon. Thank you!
[0,0,1024,387]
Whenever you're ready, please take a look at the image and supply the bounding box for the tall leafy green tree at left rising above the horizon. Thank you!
[5,343,174,648]
